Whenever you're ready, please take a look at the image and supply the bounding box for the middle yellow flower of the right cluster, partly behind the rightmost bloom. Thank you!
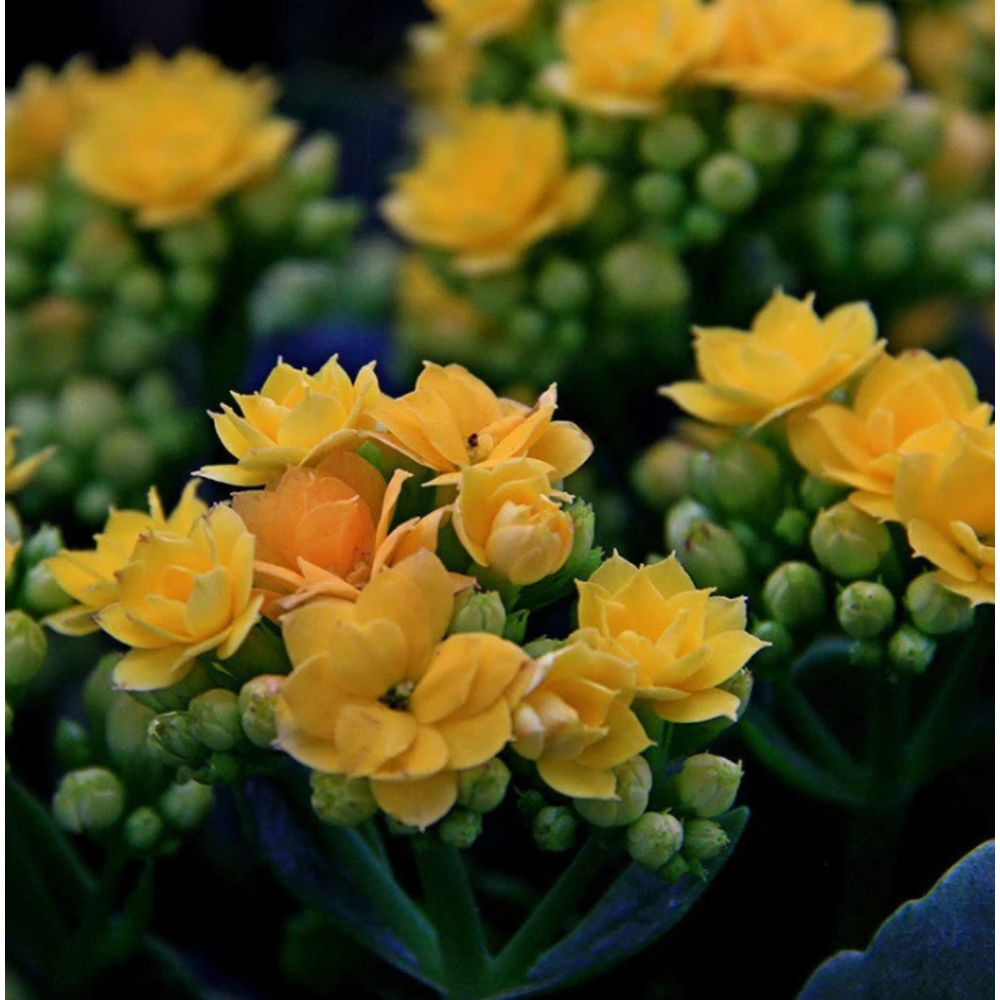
[789,351,993,521]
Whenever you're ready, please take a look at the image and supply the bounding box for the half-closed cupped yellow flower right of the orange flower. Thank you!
[455,458,573,587]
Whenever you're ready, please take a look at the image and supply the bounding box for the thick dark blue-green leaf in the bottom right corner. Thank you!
[799,843,996,1000]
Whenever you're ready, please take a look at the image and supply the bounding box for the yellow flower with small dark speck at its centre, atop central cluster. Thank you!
[372,363,594,485]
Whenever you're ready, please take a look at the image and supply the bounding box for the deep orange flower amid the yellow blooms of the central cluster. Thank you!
[233,452,456,616]
